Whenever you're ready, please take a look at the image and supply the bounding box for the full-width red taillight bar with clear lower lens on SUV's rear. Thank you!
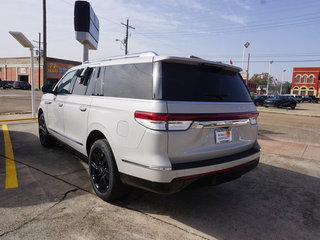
[134,111,259,131]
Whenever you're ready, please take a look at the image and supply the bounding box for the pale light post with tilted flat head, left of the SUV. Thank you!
[9,31,35,118]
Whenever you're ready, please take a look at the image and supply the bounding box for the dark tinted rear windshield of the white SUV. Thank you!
[159,62,252,102]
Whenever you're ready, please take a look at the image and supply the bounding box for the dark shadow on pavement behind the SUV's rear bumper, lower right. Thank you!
[119,163,320,240]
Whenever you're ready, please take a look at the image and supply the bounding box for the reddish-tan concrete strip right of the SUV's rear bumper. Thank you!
[258,138,320,160]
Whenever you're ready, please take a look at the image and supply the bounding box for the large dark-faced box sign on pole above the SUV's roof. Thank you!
[74,1,99,62]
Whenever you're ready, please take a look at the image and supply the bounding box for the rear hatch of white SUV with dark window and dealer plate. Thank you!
[155,61,258,165]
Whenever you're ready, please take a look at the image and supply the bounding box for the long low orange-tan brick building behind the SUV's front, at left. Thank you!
[0,57,81,88]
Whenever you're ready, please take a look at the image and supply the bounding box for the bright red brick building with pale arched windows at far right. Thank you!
[291,67,320,97]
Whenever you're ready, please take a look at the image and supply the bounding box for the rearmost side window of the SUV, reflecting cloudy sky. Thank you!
[103,63,153,99]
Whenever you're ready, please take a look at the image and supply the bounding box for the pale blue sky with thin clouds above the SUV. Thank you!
[0,0,320,81]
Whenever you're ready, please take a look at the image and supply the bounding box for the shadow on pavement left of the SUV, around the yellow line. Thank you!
[0,126,91,208]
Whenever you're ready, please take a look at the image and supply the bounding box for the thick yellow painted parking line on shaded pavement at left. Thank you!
[2,124,18,189]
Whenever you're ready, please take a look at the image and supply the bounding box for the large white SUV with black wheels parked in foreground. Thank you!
[38,53,260,201]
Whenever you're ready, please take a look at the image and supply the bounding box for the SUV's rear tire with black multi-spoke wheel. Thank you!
[89,139,127,202]
